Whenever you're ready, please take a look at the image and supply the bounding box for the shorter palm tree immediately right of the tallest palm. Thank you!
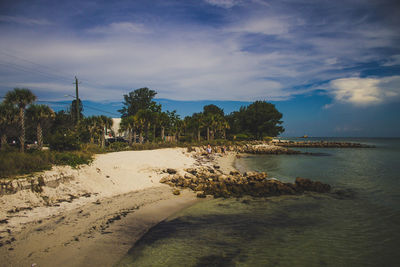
[26,105,55,150]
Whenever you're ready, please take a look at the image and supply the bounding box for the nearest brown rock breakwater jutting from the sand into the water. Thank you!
[160,167,331,198]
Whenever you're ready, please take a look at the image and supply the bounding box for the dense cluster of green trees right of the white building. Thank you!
[115,87,284,144]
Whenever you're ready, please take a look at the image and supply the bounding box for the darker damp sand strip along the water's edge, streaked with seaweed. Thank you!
[0,186,200,266]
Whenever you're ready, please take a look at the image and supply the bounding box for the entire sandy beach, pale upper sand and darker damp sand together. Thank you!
[0,148,234,266]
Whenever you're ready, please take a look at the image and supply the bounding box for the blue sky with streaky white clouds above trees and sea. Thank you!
[0,0,400,137]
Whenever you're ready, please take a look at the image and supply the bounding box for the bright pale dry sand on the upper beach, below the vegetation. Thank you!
[0,148,194,230]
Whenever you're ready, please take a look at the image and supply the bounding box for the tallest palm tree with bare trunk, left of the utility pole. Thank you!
[5,88,36,152]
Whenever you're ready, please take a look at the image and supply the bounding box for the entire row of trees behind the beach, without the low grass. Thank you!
[0,88,284,152]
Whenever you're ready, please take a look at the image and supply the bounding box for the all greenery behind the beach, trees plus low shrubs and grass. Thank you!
[0,87,284,176]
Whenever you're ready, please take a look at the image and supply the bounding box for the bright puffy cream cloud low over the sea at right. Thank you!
[330,76,400,106]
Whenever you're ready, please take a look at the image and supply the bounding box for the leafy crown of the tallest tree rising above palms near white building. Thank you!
[118,87,157,117]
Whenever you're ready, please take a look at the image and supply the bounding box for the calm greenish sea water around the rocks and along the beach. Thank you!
[119,139,400,266]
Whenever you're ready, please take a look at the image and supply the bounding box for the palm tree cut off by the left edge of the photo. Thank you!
[0,103,18,150]
